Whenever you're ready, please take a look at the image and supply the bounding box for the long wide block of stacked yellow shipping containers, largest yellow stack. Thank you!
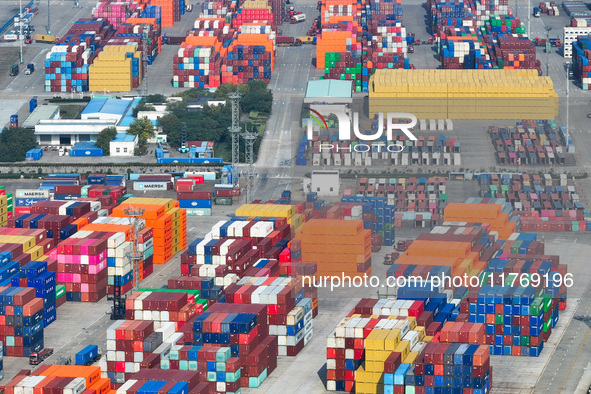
[369,70,558,119]
